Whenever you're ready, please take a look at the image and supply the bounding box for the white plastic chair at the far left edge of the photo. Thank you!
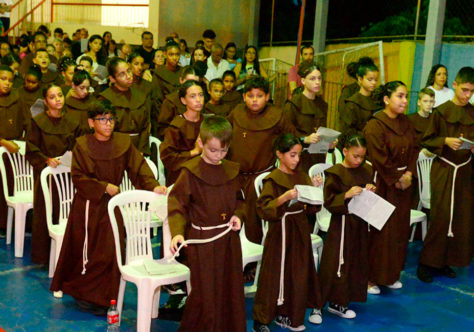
[0,141,34,257]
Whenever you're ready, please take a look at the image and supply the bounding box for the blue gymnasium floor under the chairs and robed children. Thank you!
[0,237,474,332]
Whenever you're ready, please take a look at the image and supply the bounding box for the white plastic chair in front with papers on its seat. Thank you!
[108,190,191,332]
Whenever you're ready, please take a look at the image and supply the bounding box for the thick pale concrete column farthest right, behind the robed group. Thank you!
[420,0,446,88]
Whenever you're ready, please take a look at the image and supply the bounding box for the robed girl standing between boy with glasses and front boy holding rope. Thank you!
[160,80,204,186]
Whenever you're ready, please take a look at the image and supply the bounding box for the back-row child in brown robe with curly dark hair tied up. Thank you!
[339,62,379,132]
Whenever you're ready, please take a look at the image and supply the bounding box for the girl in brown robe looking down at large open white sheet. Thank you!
[318,133,375,319]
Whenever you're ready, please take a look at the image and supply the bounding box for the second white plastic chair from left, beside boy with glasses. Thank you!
[40,165,76,278]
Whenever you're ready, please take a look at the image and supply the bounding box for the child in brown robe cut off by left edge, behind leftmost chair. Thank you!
[0,65,31,237]
